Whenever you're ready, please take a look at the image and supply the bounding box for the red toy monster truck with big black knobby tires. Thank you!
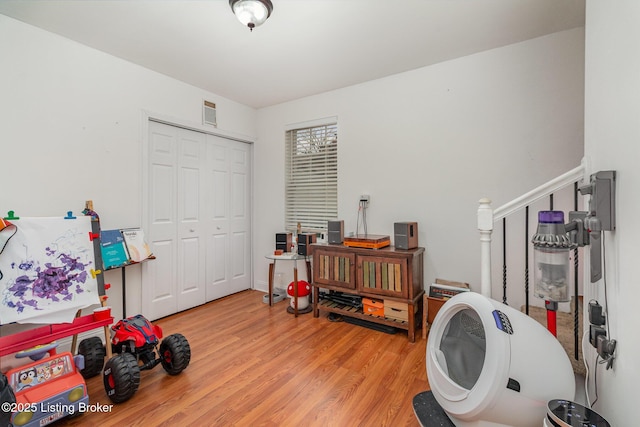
[102,314,191,403]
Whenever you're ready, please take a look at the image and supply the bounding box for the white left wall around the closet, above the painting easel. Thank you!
[0,15,256,324]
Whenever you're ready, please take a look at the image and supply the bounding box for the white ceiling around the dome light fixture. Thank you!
[0,0,585,108]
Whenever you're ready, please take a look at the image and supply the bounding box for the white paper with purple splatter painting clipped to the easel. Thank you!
[0,216,100,324]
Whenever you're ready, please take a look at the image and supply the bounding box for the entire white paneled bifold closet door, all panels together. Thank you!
[142,121,251,320]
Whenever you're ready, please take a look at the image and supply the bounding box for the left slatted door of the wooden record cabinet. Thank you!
[313,250,356,289]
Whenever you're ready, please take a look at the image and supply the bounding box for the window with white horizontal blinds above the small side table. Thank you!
[285,123,338,232]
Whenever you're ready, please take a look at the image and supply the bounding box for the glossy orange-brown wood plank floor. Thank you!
[54,291,428,427]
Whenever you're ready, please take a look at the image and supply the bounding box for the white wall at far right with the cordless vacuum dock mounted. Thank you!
[585,0,640,426]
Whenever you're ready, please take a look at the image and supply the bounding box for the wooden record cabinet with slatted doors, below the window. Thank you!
[309,243,424,342]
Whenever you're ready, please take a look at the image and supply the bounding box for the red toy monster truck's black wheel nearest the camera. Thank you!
[102,353,140,403]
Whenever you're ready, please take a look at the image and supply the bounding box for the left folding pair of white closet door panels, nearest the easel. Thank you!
[142,122,206,320]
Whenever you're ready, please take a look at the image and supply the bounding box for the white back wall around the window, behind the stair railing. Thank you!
[254,29,584,300]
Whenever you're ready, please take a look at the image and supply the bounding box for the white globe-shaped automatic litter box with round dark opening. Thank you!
[426,292,575,427]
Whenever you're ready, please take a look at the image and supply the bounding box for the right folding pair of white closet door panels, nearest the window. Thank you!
[206,135,251,301]
